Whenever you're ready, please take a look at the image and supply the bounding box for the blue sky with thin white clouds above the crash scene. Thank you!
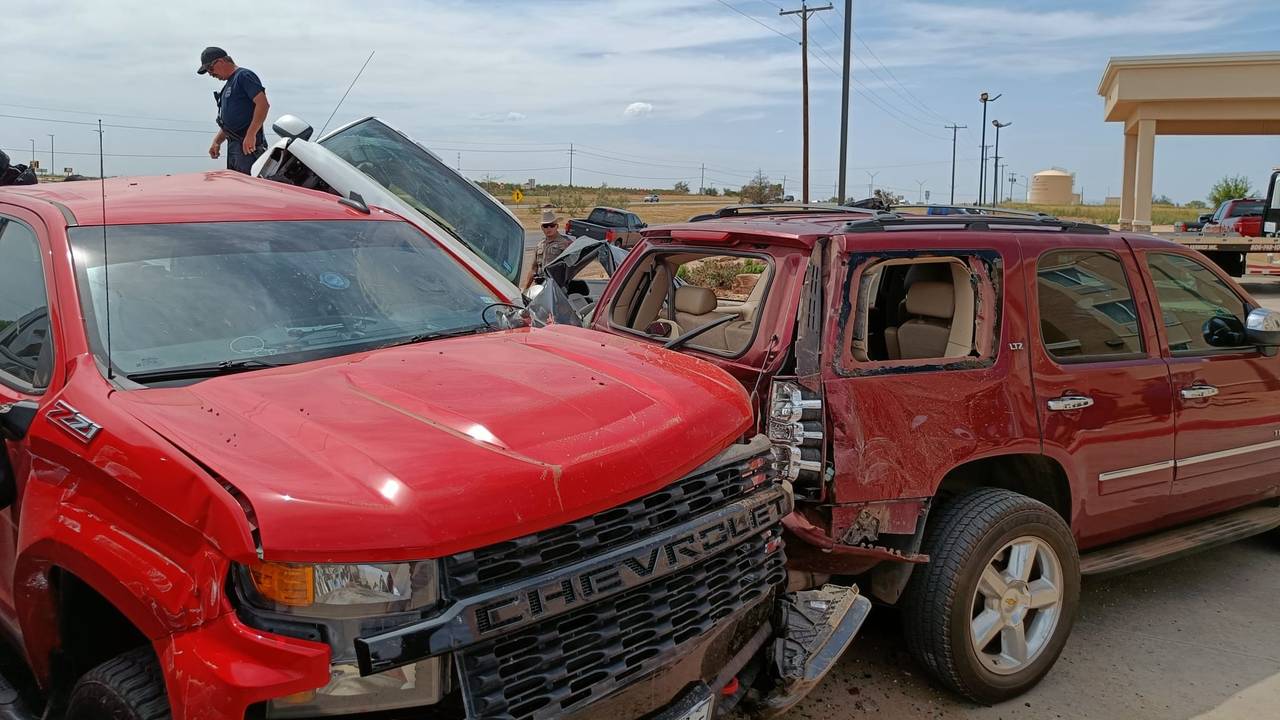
[0,0,1280,202]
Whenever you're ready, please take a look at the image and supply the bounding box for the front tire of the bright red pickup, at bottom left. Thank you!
[64,647,172,720]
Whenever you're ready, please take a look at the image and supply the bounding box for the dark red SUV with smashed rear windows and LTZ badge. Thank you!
[563,208,1280,702]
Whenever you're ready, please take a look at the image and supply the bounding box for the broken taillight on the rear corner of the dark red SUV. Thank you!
[769,380,823,491]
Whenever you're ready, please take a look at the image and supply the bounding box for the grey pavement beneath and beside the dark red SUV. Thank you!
[762,275,1280,720]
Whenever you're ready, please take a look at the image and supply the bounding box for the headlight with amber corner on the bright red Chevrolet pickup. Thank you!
[233,561,449,719]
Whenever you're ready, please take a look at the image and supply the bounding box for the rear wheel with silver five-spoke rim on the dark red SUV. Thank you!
[902,488,1080,703]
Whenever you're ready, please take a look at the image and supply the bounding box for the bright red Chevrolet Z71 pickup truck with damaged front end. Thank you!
[0,172,869,720]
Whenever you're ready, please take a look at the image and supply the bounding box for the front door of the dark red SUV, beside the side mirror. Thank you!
[1135,241,1280,515]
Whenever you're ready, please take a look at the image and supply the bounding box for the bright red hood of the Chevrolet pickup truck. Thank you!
[113,327,751,561]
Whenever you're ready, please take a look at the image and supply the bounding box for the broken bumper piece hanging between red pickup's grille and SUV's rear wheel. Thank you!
[754,584,872,719]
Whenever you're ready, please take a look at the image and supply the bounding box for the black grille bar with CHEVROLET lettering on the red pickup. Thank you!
[356,487,792,675]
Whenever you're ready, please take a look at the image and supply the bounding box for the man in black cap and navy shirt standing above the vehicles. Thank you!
[196,47,270,174]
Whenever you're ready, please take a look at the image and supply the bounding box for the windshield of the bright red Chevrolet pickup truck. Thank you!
[70,220,497,382]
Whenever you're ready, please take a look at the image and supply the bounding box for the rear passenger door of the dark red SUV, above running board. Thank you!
[1020,233,1174,547]
